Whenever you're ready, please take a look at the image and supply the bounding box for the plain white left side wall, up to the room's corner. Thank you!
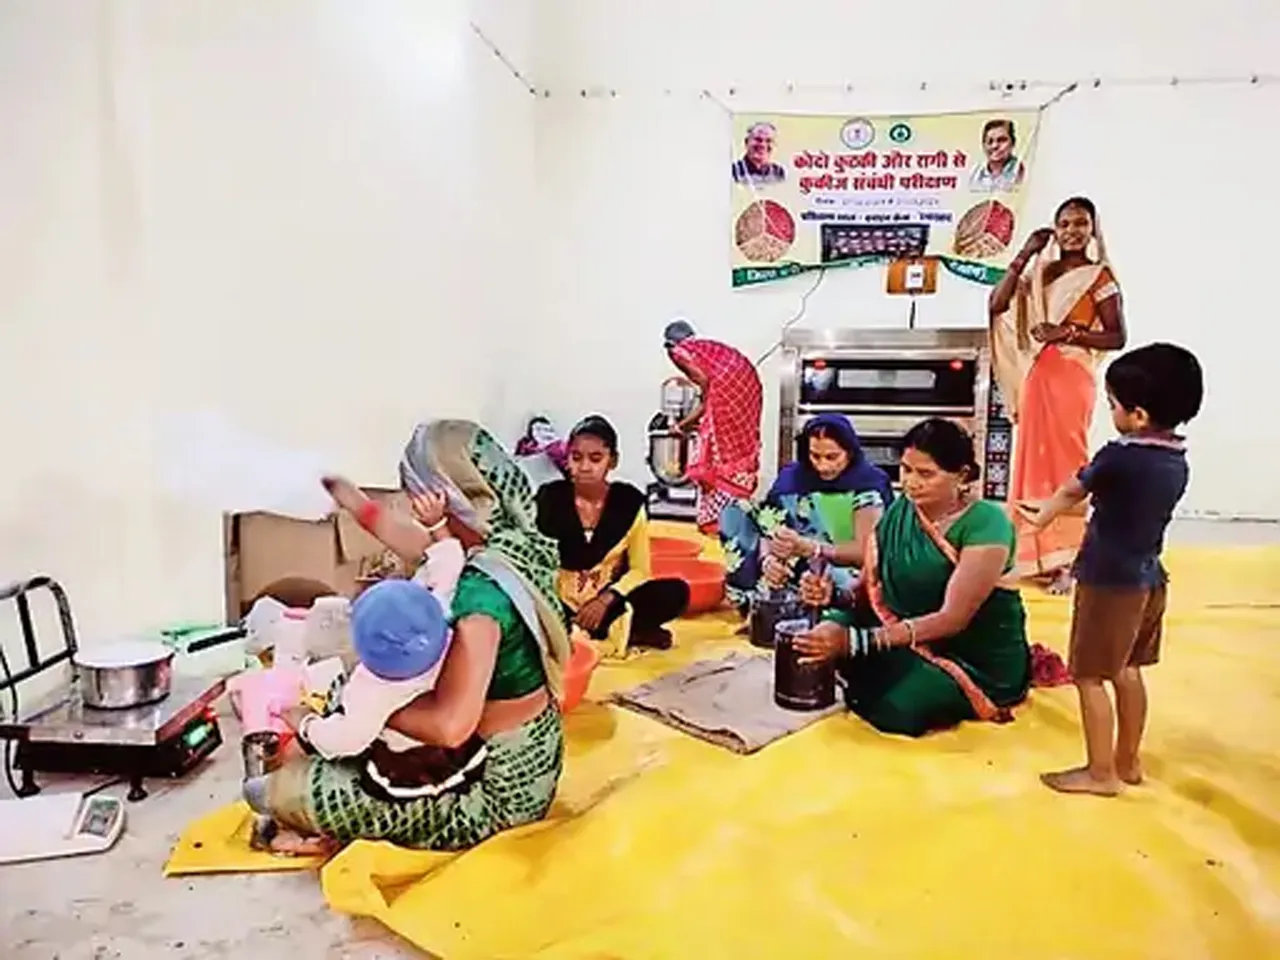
[0,0,535,639]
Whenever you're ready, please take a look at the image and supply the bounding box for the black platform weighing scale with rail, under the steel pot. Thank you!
[0,576,225,803]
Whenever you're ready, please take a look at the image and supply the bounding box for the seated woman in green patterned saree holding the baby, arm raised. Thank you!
[256,420,570,852]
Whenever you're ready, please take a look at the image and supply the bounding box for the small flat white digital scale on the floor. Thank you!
[0,794,124,864]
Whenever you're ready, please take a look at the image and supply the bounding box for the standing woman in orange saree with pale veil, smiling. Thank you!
[988,197,1125,593]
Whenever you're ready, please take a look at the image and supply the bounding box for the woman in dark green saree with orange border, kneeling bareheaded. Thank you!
[796,419,1032,736]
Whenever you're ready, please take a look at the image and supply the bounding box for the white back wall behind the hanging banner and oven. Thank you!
[527,0,1280,517]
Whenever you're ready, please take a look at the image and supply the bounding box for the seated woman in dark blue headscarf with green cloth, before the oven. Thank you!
[721,413,893,604]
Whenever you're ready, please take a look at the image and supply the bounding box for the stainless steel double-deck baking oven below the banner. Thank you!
[778,328,1012,500]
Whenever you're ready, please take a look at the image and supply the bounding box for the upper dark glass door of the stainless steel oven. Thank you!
[800,357,978,413]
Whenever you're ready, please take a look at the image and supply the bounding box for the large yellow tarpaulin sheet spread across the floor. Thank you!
[189,529,1280,960]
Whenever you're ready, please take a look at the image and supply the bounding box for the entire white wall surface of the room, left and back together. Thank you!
[0,0,1280,660]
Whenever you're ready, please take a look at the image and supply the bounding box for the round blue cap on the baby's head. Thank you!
[351,580,449,680]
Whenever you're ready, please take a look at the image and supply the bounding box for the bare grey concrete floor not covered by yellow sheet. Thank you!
[0,521,1280,960]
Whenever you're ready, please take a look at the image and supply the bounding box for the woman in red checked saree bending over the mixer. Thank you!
[662,320,764,534]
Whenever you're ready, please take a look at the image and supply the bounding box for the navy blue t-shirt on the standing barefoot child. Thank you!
[1075,438,1189,589]
